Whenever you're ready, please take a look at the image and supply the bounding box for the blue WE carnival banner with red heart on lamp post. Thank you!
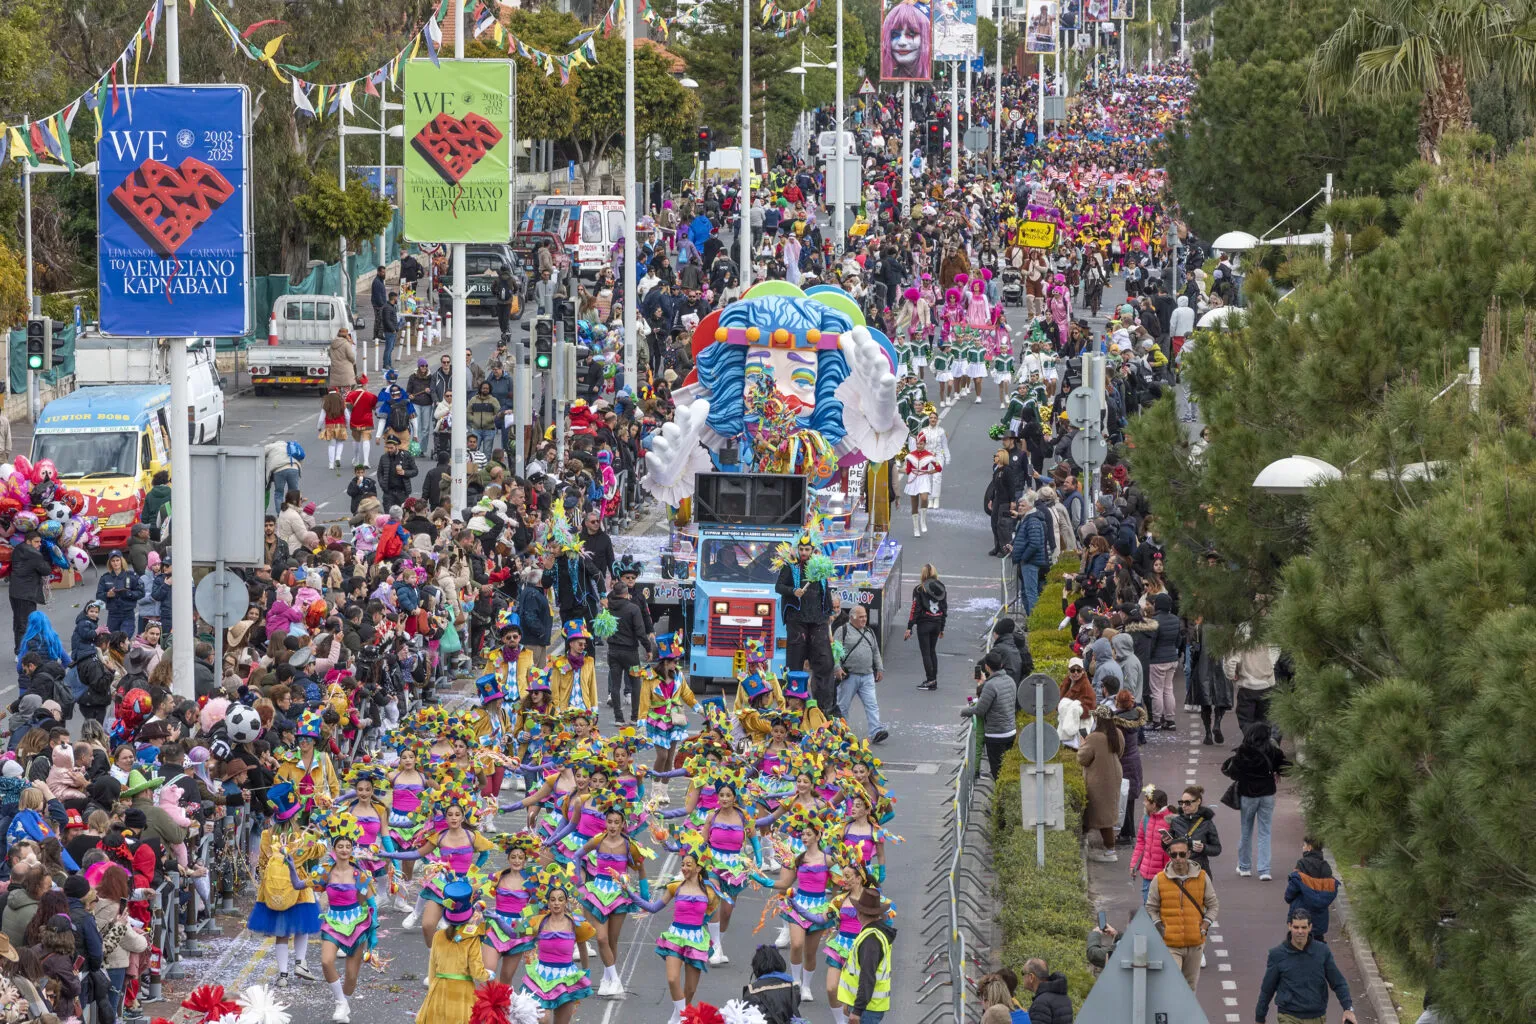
[97,86,252,338]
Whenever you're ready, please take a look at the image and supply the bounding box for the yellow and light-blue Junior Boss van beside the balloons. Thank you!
[32,384,174,548]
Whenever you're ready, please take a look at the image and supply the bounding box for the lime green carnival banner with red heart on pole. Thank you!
[401,60,511,244]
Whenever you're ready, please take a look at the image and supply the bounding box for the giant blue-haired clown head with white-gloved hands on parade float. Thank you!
[647,281,906,504]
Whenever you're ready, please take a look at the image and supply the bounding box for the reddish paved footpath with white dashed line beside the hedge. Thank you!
[1087,711,1378,1024]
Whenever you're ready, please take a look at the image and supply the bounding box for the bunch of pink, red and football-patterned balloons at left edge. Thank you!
[0,454,100,579]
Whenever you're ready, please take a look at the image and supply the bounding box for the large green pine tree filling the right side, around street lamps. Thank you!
[1130,135,1536,1024]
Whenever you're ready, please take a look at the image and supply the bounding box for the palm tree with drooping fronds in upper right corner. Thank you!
[1307,0,1536,164]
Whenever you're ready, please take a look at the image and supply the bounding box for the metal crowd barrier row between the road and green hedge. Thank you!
[917,718,992,1024]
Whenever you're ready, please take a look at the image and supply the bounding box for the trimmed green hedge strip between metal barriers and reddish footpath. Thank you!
[992,559,1095,1006]
